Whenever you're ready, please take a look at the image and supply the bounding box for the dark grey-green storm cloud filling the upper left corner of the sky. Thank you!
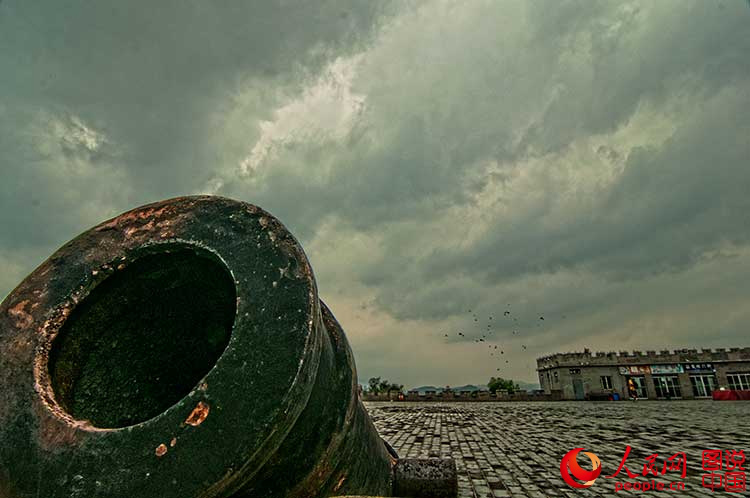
[0,2,388,251]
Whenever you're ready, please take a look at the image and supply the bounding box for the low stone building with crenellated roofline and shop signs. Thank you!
[537,348,750,400]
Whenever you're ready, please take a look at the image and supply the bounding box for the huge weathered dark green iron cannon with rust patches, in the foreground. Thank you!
[0,196,457,498]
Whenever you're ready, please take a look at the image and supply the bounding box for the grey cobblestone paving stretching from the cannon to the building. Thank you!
[365,400,750,498]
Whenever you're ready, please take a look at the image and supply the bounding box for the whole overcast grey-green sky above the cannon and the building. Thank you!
[0,0,750,386]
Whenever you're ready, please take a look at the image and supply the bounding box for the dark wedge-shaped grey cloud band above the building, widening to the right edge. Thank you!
[426,88,750,290]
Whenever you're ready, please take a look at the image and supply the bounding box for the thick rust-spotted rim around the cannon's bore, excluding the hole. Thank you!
[0,196,324,497]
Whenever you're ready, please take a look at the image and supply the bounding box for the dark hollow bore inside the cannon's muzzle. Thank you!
[49,249,236,428]
